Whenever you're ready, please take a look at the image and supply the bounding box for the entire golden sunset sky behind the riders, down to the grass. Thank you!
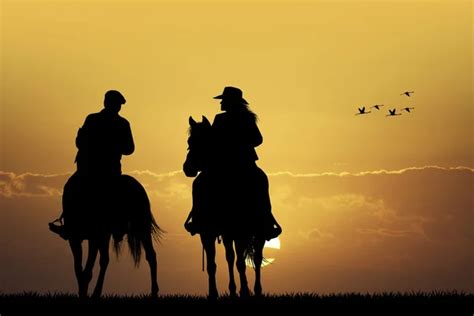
[0,0,474,294]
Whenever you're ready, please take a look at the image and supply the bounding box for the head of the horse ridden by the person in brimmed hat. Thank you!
[183,116,212,177]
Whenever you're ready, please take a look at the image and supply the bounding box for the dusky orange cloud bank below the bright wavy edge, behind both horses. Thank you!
[0,166,474,293]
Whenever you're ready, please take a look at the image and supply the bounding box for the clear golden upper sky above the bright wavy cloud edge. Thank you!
[0,0,473,173]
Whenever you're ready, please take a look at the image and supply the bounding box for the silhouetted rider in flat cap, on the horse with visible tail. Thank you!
[50,90,135,239]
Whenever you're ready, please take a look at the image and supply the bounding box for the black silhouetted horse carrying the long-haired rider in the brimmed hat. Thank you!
[183,116,281,299]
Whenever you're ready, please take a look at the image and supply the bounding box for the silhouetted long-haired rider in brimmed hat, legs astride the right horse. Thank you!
[185,87,281,239]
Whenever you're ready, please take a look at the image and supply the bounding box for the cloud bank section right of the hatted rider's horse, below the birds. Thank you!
[264,166,474,290]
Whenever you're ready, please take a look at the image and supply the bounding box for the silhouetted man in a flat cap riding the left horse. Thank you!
[50,90,135,239]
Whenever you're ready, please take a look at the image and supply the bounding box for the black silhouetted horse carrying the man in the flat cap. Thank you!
[58,174,162,298]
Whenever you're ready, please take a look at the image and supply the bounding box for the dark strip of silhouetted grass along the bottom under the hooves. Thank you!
[0,291,474,316]
